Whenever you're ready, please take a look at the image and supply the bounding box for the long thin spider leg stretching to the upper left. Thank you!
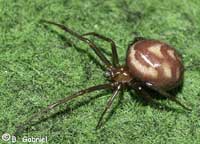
[41,20,112,69]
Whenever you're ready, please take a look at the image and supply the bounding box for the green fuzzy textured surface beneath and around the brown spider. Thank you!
[0,0,200,144]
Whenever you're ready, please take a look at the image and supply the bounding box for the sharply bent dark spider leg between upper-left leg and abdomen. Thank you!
[82,32,119,67]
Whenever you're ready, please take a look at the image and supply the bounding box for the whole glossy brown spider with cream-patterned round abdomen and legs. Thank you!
[16,20,191,133]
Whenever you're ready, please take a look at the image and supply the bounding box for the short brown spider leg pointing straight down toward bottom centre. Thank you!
[96,85,121,129]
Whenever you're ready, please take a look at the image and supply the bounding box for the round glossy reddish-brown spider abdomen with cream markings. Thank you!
[126,40,183,89]
